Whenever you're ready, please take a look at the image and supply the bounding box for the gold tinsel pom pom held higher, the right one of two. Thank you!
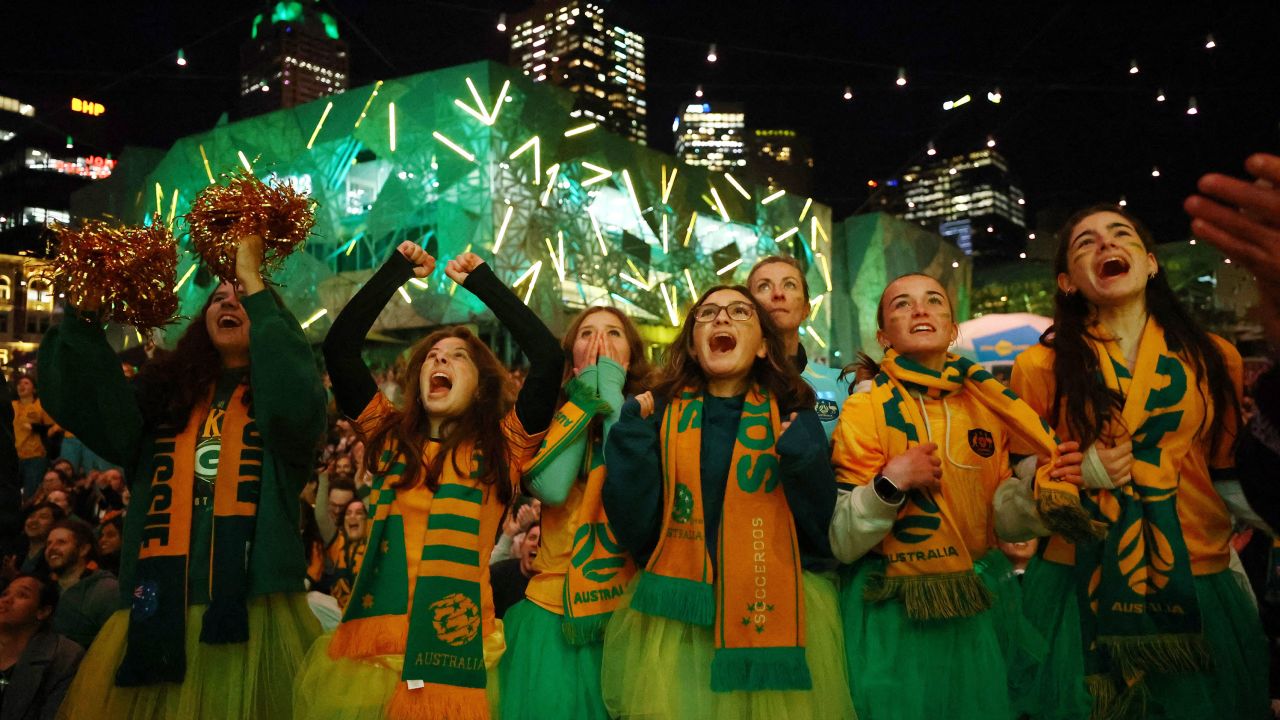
[187,173,316,281]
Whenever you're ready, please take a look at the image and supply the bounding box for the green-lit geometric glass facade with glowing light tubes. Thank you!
[77,63,833,356]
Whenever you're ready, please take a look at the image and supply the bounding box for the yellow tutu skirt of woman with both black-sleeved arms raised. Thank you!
[293,620,507,720]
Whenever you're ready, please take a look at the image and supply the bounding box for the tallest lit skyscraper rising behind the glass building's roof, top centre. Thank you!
[511,0,649,145]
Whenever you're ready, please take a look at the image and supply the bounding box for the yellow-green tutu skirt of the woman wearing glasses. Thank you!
[596,571,855,720]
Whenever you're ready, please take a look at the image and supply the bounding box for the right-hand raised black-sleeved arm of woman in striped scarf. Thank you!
[444,252,564,434]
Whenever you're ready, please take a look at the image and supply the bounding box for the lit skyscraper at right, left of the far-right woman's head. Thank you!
[876,149,1027,260]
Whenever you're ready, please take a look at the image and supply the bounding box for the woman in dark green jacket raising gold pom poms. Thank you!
[40,237,325,720]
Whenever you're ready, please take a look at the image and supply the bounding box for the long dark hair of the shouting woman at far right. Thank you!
[1041,204,1240,448]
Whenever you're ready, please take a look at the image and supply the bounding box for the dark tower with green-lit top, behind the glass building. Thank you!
[239,0,351,118]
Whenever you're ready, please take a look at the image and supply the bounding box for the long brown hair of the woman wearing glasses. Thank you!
[653,284,817,414]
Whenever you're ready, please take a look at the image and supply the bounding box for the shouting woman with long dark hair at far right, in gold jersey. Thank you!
[1012,205,1267,720]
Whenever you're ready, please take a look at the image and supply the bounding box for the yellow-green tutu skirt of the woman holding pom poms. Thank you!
[58,593,320,720]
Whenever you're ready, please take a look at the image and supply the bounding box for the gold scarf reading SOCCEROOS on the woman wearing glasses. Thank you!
[631,387,813,692]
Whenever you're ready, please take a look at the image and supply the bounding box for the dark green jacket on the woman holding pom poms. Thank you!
[40,291,325,607]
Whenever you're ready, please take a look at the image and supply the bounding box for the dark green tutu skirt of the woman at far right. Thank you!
[1014,557,1271,720]
